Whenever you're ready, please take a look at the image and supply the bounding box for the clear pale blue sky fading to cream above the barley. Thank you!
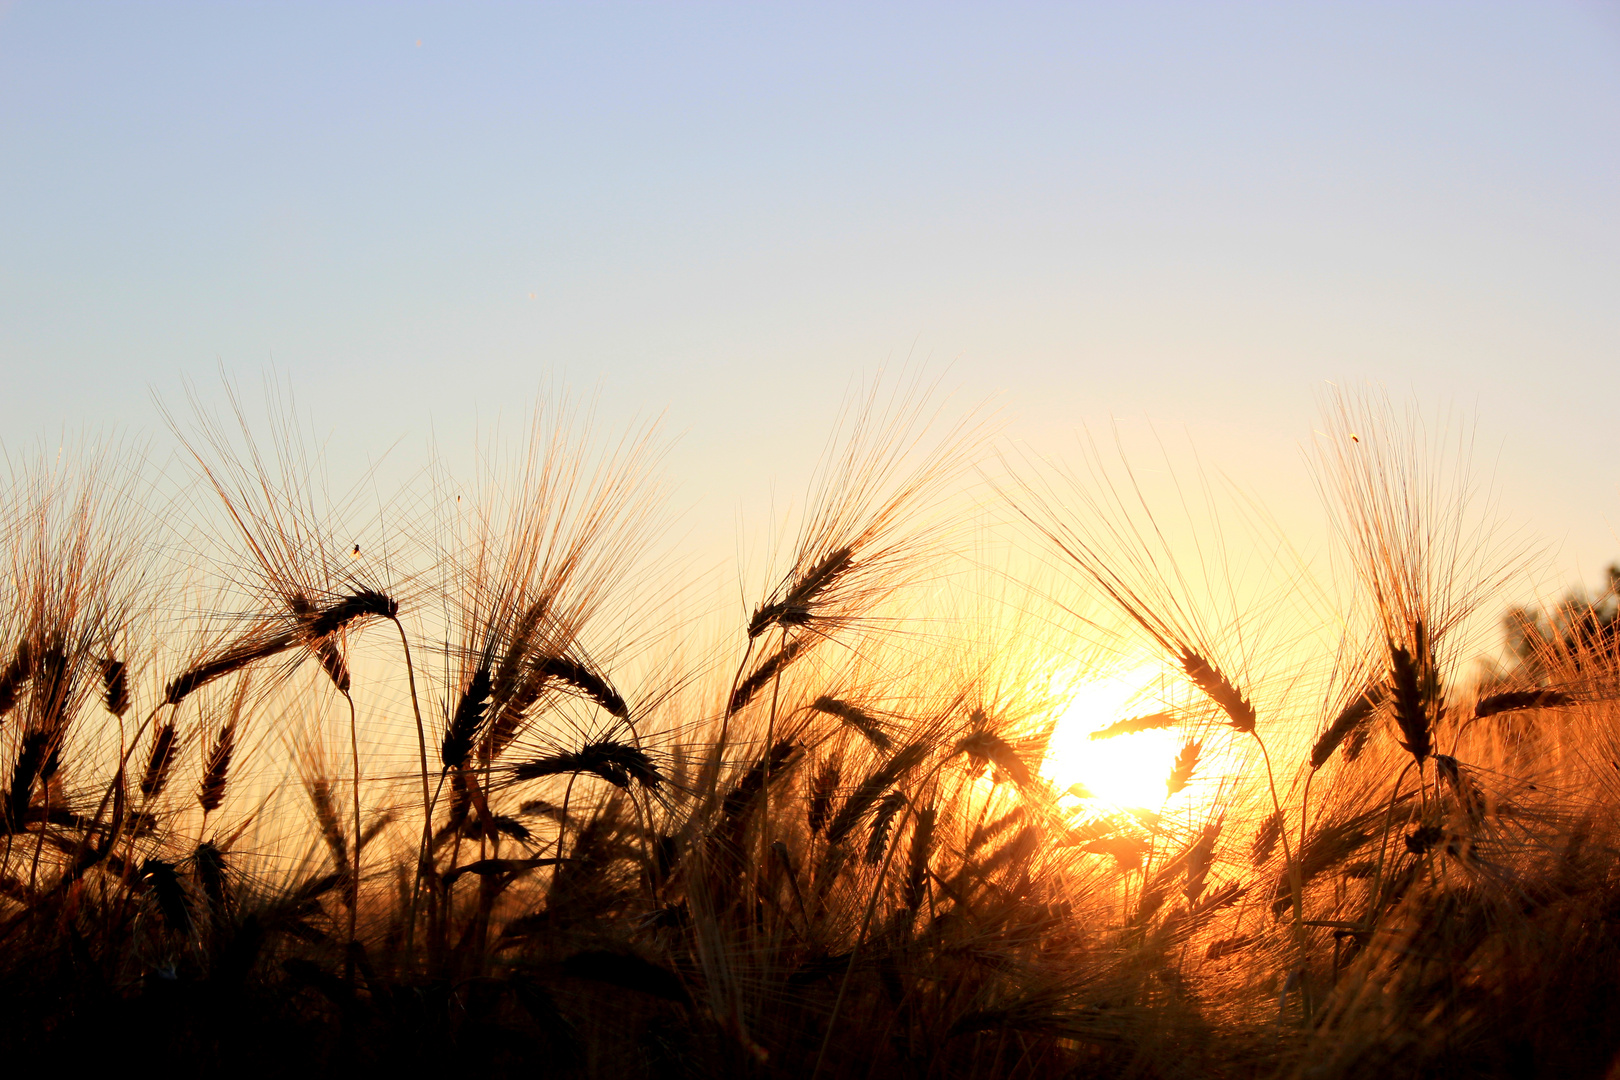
[0,2,1620,608]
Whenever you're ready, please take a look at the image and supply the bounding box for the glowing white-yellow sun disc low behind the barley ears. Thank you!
[1043,662,1181,810]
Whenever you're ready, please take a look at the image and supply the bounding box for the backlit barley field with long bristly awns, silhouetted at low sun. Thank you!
[0,384,1620,1080]
